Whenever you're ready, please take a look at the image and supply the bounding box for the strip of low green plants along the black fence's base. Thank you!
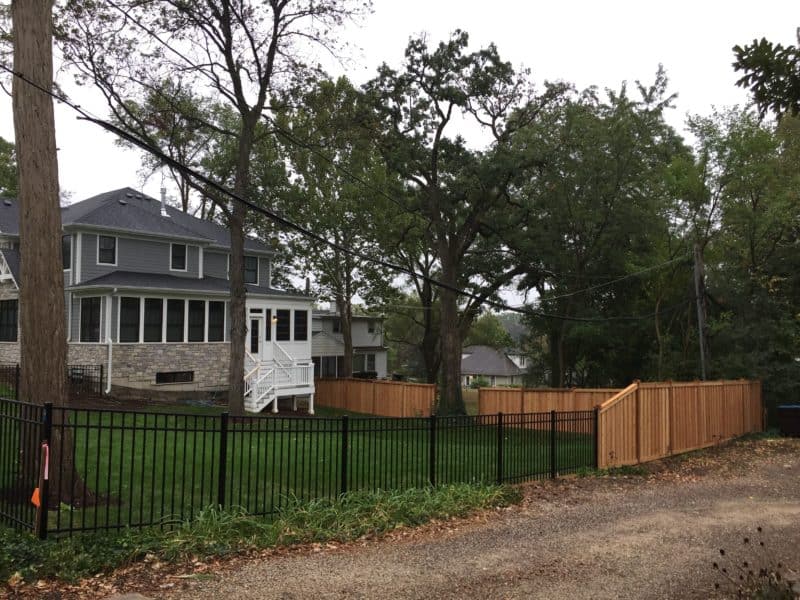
[0,484,520,582]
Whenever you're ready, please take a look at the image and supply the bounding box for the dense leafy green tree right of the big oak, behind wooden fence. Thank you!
[520,71,688,387]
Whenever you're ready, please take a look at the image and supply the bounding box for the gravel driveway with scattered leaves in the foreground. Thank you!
[153,440,800,599]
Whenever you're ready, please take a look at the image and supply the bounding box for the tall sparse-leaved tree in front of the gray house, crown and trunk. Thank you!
[63,0,364,414]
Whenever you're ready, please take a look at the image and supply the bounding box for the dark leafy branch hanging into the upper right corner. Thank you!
[733,29,800,117]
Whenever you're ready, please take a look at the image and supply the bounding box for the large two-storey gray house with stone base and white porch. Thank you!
[0,188,314,412]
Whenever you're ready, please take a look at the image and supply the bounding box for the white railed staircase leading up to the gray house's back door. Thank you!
[244,344,314,414]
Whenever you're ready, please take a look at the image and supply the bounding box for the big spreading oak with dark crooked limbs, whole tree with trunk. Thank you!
[366,31,559,414]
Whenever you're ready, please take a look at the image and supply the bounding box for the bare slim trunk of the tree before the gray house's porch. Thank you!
[228,119,255,415]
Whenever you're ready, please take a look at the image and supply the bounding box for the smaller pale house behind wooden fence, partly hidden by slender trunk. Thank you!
[311,310,387,379]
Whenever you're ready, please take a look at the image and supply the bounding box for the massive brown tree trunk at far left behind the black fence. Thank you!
[12,0,88,506]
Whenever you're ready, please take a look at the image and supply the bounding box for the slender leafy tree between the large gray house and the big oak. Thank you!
[278,78,391,377]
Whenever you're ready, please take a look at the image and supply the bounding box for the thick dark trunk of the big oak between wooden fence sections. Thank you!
[438,258,467,415]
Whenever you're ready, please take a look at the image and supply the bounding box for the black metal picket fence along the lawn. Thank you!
[0,400,597,536]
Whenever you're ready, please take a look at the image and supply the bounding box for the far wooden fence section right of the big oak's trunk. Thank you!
[478,388,619,415]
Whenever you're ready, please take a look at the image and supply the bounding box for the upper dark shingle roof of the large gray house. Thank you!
[0,187,274,253]
